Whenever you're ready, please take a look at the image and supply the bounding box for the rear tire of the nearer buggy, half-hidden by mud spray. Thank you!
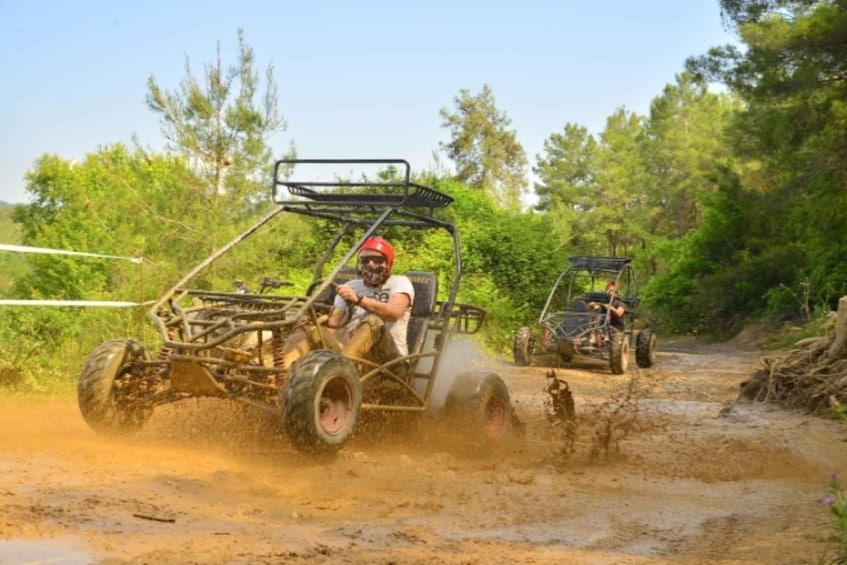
[444,370,515,441]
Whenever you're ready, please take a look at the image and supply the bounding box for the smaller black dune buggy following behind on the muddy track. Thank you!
[513,256,656,375]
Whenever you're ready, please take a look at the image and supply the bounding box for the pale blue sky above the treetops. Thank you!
[0,0,733,202]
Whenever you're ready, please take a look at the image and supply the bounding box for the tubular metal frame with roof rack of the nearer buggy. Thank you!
[144,159,485,411]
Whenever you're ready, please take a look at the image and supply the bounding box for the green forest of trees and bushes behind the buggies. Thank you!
[0,0,847,390]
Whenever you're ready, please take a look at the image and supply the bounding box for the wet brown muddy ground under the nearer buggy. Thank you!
[0,340,847,564]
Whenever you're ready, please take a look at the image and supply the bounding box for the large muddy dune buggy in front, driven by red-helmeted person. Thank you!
[78,159,518,454]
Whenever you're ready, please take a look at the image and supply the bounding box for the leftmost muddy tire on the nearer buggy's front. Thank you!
[77,339,152,434]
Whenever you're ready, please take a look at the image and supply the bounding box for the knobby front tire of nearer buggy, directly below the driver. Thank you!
[280,349,362,455]
